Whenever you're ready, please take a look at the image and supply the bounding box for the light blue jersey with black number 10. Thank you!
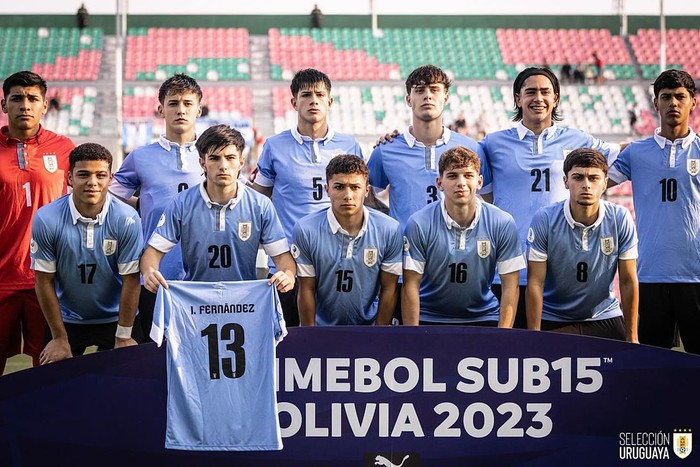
[608,129,700,283]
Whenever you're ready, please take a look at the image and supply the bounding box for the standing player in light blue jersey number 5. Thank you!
[253,68,362,326]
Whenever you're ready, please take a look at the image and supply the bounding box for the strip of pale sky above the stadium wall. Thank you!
[8,0,700,16]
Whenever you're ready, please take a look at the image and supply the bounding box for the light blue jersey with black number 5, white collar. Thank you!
[255,127,362,243]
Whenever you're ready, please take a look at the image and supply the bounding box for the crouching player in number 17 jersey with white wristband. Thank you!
[31,143,143,365]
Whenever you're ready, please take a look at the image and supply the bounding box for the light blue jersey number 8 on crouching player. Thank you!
[528,200,637,322]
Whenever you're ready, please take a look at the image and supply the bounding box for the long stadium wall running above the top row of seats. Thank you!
[0,15,700,35]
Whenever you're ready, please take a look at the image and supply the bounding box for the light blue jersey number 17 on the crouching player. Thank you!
[30,194,143,324]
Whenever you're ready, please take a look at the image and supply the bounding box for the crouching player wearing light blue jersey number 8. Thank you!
[526,148,639,342]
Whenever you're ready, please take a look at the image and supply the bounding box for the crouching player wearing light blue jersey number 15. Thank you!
[292,154,403,326]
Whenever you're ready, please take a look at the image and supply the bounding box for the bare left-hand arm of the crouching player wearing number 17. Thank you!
[34,270,73,365]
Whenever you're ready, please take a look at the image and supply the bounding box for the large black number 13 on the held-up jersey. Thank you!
[202,323,245,379]
